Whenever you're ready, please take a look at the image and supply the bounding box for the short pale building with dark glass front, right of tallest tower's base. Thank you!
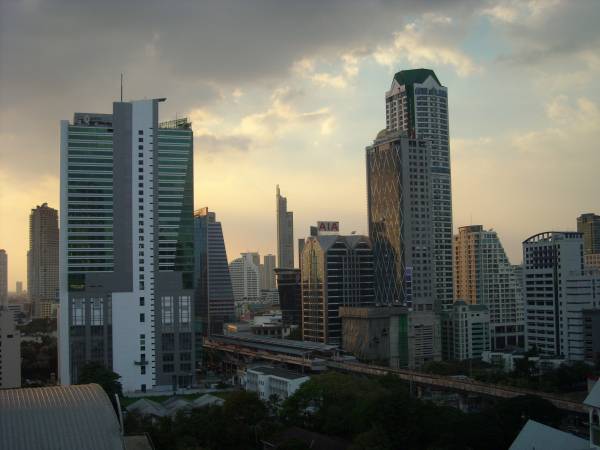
[442,300,491,361]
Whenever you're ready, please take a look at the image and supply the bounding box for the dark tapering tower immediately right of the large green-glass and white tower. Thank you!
[194,208,235,336]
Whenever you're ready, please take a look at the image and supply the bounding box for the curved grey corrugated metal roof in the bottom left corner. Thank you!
[0,384,124,450]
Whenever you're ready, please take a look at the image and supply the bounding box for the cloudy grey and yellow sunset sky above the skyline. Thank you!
[0,0,600,290]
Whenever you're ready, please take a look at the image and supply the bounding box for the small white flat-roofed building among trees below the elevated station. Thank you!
[242,366,310,400]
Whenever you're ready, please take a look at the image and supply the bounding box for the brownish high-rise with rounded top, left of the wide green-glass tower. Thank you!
[27,203,59,316]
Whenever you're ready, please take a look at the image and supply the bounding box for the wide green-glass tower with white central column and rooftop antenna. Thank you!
[59,99,195,392]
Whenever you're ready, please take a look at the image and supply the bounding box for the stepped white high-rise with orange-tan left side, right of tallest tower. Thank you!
[454,225,525,350]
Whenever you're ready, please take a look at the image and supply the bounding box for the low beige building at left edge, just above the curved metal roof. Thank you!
[0,306,21,389]
